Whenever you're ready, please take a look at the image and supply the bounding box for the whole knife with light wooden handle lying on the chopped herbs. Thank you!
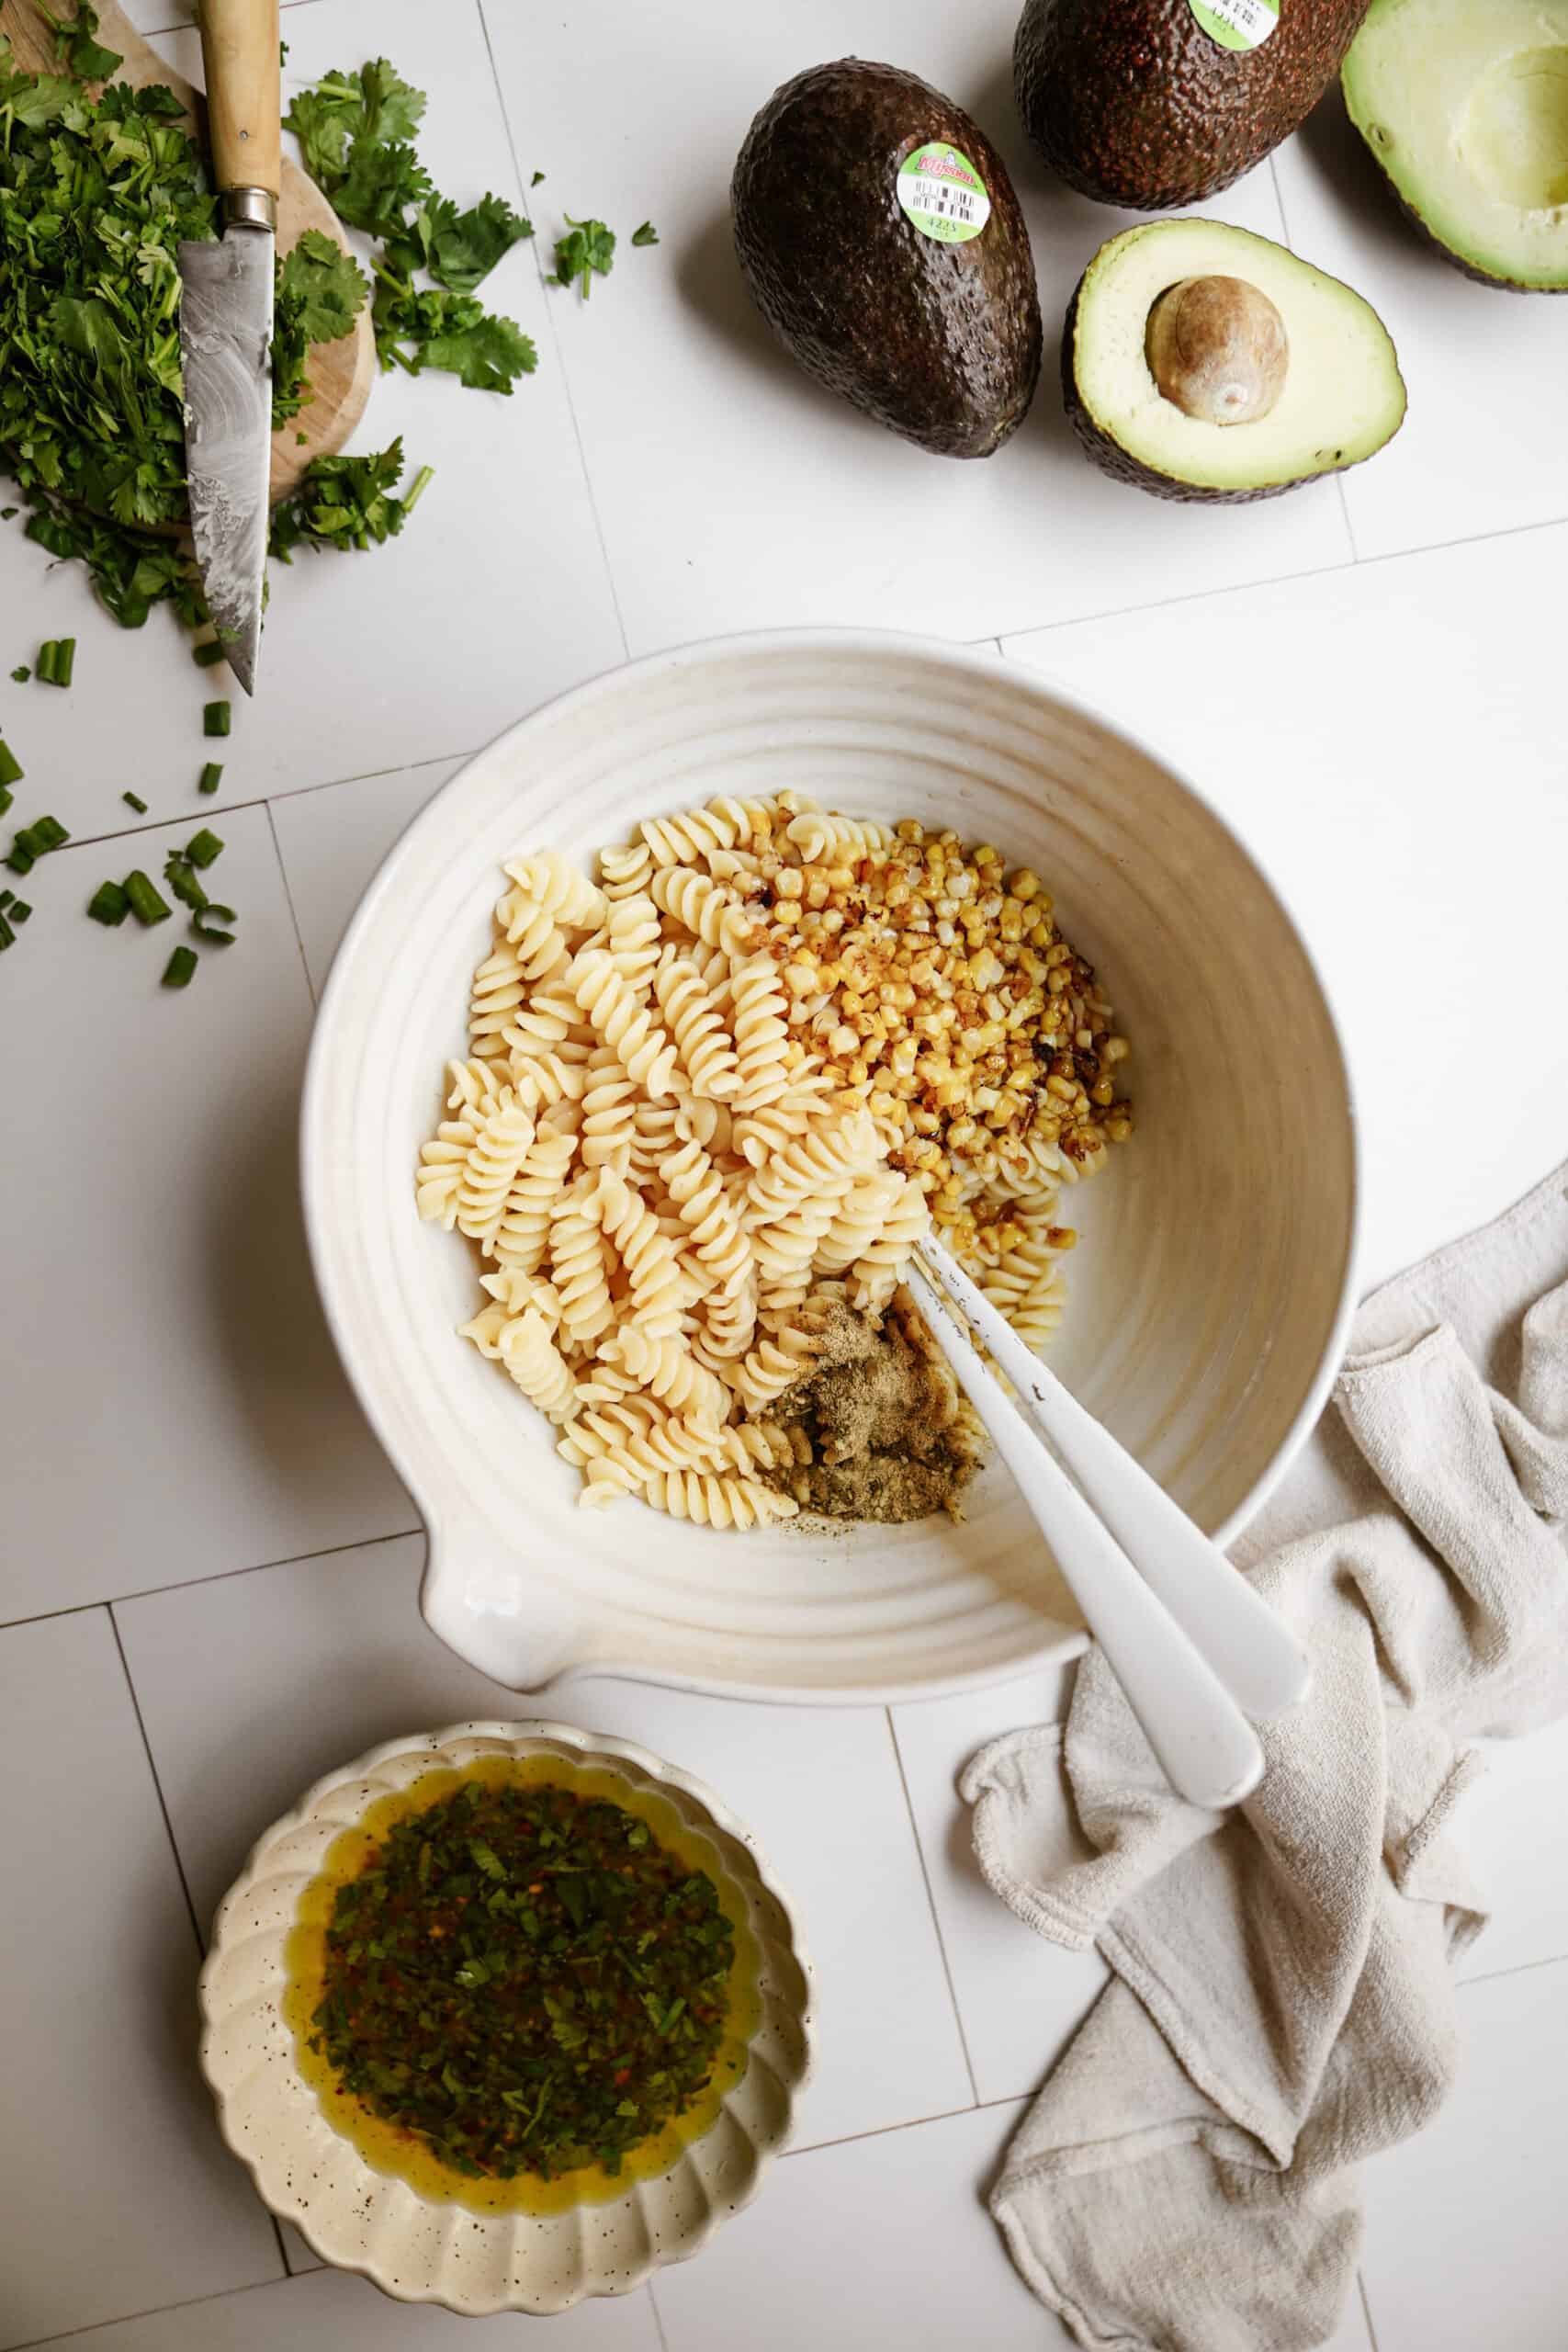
[179,0,280,694]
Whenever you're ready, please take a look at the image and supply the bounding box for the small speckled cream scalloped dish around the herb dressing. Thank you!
[200,1722,811,2314]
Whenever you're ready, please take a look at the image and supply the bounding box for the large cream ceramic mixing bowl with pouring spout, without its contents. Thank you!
[303,633,1357,1705]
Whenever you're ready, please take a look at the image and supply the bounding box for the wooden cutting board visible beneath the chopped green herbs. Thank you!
[5,0,376,499]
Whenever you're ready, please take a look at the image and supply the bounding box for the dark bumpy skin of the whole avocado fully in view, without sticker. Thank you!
[731,56,1043,457]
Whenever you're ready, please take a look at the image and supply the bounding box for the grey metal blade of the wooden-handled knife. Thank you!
[179,226,277,694]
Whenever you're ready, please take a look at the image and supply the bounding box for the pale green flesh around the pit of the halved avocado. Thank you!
[1063,221,1405,499]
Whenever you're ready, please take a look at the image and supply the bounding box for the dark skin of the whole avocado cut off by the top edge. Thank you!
[1013,0,1368,211]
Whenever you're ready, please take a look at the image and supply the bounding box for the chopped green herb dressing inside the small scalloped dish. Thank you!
[310,1781,736,2180]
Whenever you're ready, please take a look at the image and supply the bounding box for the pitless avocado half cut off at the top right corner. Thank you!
[1340,0,1568,294]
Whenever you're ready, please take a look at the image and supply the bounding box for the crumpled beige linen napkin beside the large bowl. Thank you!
[962,1169,1568,2352]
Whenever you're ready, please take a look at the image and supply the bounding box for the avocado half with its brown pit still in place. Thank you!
[1063,221,1405,499]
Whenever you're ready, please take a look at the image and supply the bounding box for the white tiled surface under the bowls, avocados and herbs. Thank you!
[0,0,1568,2352]
